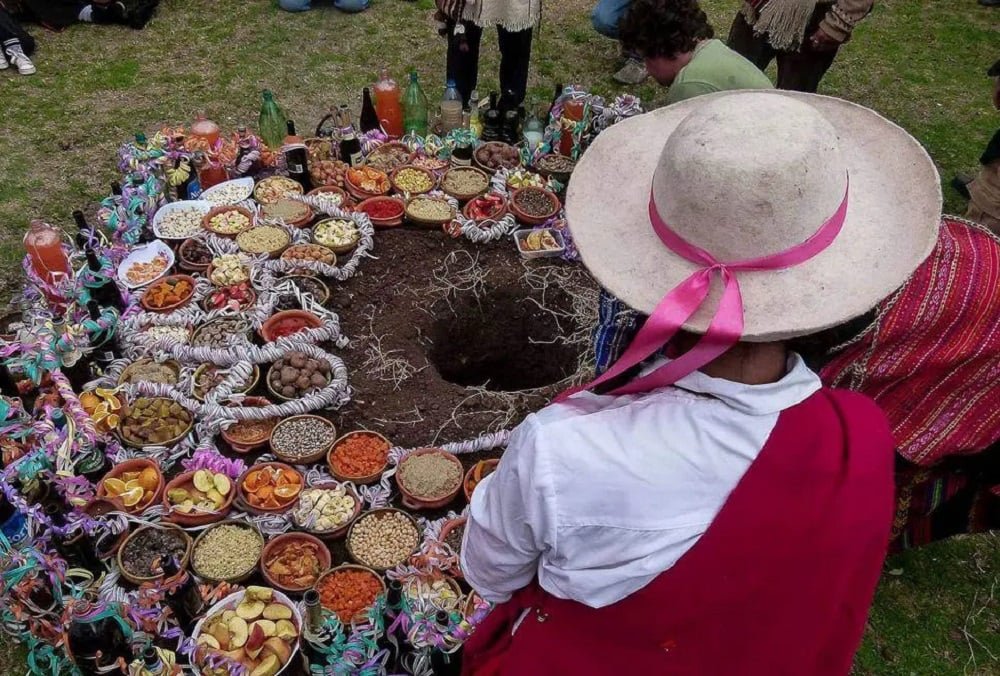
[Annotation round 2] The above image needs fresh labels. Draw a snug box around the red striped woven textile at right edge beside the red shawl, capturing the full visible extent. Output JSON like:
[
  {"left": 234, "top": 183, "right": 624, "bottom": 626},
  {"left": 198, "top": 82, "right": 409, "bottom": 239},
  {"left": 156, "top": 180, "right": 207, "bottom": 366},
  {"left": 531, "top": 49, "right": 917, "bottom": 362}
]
[{"left": 821, "top": 217, "right": 1000, "bottom": 466}]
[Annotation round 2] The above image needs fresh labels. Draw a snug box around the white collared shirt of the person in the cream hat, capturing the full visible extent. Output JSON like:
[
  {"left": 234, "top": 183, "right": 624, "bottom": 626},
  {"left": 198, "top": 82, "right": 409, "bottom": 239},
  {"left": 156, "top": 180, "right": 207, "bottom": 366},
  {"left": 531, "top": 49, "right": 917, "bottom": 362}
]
[{"left": 462, "top": 355, "right": 821, "bottom": 608}]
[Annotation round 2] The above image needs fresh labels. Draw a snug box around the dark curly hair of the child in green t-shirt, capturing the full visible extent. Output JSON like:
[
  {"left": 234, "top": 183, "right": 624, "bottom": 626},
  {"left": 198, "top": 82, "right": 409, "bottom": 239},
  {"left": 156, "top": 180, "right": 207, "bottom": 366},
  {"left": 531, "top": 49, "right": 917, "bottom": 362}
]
[{"left": 618, "top": 0, "right": 715, "bottom": 59}]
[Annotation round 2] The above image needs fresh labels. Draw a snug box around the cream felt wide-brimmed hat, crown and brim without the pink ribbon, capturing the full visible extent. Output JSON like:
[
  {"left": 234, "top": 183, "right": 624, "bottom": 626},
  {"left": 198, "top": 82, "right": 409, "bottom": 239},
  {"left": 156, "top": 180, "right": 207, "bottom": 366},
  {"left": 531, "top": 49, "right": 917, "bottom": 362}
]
[{"left": 566, "top": 91, "right": 941, "bottom": 342}]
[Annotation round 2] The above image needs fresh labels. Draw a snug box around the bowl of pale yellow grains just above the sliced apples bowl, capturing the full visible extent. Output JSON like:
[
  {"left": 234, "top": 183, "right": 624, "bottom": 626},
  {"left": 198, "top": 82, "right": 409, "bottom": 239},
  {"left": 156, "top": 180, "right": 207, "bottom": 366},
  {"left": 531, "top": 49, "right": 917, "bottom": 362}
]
[{"left": 191, "top": 520, "right": 264, "bottom": 582}]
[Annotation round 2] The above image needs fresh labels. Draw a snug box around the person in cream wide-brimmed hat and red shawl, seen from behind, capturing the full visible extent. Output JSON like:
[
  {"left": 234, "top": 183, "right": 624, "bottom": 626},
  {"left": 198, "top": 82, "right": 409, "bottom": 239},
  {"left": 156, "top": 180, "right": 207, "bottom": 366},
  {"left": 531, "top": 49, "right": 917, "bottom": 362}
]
[{"left": 462, "top": 92, "right": 941, "bottom": 676}]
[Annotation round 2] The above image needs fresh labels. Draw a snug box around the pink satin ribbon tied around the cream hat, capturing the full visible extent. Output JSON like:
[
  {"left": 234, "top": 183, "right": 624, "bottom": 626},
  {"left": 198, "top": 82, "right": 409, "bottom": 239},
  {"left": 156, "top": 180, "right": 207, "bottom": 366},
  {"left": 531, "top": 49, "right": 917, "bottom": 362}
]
[{"left": 556, "top": 177, "right": 850, "bottom": 402}]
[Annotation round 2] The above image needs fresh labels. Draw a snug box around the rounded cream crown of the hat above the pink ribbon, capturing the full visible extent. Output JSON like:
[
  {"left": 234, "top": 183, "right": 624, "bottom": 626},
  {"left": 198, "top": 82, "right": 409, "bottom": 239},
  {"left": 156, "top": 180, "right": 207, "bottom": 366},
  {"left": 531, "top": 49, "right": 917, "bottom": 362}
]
[{"left": 653, "top": 92, "right": 847, "bottom": 262}]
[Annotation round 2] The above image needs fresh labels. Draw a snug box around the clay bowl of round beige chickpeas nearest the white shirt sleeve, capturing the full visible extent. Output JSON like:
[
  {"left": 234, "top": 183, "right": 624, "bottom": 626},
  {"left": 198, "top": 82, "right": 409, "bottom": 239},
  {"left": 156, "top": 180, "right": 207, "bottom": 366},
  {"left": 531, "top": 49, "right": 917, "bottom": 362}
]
[{"left": 347, "top": 508, "right": 421, "bottom": 572}]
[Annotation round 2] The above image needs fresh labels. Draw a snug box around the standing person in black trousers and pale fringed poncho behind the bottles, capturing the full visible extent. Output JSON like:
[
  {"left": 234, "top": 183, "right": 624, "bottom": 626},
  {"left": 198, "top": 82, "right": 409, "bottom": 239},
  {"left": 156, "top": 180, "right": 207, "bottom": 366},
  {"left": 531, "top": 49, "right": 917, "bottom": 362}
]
[{"left": 435, "top": 0, "right": 542, "bottom": 110}]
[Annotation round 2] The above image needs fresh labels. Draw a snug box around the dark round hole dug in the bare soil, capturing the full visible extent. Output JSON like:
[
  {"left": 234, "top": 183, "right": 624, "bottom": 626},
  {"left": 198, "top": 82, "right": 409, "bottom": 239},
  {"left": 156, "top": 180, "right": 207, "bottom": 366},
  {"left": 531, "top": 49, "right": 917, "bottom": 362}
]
[{"left": 430, "top": 286, "right": 580, "bottom": 392}]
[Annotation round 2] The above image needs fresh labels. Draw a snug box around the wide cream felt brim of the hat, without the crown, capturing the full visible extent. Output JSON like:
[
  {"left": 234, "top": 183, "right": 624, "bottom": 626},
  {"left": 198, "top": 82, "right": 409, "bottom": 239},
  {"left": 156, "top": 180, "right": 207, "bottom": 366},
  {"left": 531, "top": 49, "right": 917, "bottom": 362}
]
[{"left": 566, "top": 91, "right": 941, "bottom": 342}]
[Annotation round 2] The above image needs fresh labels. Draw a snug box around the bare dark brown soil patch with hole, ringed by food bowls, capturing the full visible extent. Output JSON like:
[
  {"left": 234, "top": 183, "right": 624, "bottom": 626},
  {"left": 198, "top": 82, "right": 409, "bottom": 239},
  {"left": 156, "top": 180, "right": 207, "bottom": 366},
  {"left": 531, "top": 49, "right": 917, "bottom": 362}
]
[{"left": 318, "top": 229, "right": 579, "bottom": 447}]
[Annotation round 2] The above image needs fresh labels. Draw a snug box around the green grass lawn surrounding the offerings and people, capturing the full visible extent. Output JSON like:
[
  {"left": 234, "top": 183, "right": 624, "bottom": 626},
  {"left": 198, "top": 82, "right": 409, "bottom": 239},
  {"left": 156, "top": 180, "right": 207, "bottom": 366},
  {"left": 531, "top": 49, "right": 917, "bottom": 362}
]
[{"left": 0, "top": 0, "right": 1000, "bottom": 676}]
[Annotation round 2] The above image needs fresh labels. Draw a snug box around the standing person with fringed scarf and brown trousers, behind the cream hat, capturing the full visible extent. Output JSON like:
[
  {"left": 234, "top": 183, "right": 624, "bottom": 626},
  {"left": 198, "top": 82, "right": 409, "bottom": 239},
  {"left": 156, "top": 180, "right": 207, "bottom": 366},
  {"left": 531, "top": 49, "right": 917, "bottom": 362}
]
[{"left": 729, "top": 0, "right": 875, "bottom": 93}]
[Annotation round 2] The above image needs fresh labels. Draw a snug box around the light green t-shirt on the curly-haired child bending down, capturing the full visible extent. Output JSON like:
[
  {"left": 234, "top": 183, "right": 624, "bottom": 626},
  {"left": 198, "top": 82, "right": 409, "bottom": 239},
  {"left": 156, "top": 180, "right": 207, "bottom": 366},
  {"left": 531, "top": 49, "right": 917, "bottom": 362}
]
[{"left": 667, "top": 40, "right": 774, "bottom": 104}]
